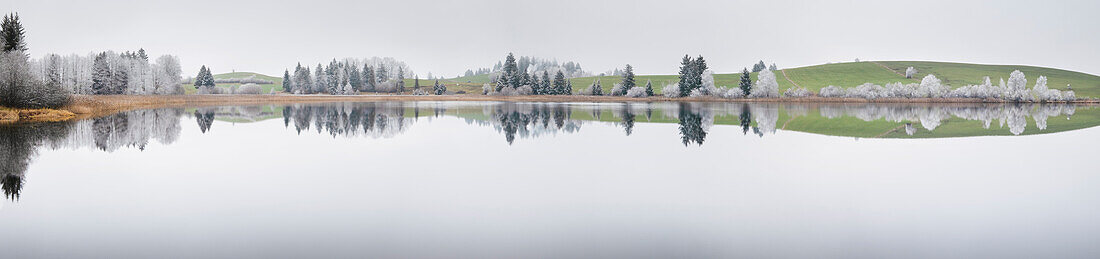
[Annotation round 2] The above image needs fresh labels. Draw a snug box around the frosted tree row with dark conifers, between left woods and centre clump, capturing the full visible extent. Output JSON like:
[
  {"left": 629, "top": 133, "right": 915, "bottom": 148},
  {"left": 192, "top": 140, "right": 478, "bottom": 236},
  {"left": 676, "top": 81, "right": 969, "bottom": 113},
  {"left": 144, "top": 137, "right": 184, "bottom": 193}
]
[{"left": 283, "top": 57, "right": 411, "bottom": 95}]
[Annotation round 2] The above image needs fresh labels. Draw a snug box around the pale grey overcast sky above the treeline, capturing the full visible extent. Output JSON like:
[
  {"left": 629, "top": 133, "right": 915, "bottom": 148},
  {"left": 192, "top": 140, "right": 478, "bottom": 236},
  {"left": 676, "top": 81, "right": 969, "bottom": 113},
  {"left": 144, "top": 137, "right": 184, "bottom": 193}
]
[{"left": 0, "top": 0, "right": 1100, "bottom": 77}]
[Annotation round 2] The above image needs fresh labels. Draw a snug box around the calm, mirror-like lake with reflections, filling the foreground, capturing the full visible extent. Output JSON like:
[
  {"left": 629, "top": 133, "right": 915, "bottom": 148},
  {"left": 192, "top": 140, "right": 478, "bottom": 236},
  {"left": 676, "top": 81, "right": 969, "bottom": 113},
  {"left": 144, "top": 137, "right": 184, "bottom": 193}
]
[{"left": 0, "top": 101, "right": 1100, "bottom": 258}]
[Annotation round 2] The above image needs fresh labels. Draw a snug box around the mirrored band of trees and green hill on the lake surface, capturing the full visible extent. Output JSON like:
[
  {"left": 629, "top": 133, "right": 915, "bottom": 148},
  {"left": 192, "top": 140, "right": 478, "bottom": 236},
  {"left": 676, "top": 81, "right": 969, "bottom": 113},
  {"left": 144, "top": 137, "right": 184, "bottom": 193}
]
[{"left": 0, "top": 102, "right": 1100, "bottom": 199}]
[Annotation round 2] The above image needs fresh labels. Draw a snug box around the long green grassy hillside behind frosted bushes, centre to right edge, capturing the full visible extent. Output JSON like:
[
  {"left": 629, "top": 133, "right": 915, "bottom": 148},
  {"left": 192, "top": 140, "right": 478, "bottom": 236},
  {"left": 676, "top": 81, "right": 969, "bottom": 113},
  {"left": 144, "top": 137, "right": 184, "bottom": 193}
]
[{"left": 446, "top": 61, "right": 1100, "bottom": 97}]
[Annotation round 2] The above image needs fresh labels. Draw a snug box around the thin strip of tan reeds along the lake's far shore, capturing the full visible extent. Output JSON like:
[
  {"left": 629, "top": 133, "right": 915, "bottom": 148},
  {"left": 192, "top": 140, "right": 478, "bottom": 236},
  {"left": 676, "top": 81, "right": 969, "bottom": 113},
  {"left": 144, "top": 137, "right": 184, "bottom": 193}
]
[{"left": 0, "top": 94, "right": 1100, "bottom": 125}]
